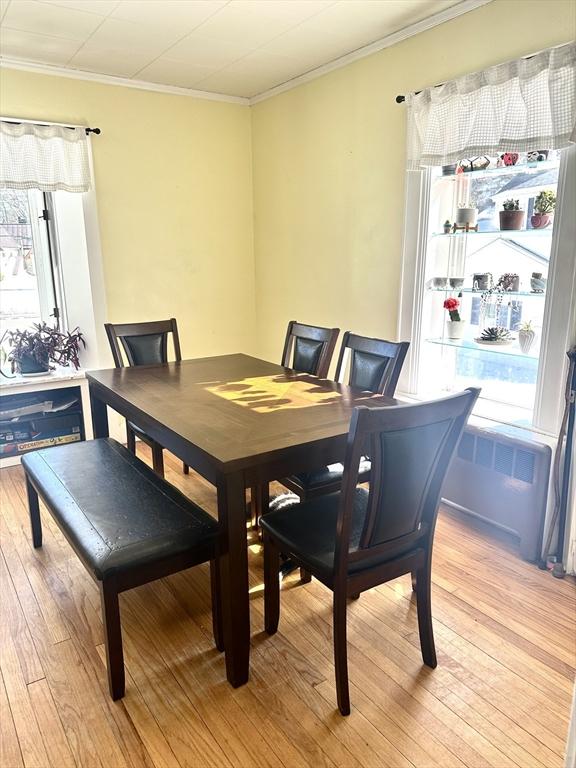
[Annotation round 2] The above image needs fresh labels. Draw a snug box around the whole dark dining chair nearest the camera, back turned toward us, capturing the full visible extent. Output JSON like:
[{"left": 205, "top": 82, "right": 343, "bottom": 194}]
[{"left": 261, "top": 388, "right": 480, "bottom": 715}]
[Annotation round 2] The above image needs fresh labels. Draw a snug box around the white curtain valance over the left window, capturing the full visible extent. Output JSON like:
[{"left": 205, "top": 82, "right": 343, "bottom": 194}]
[{"left": 0, "top": 121, "right": 90, "bottom": 192}]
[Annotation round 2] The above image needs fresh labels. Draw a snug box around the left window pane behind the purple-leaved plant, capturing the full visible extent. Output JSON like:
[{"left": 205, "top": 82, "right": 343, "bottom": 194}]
[{"left": 0, "top": 189, "right": 62, "bottom": 336}]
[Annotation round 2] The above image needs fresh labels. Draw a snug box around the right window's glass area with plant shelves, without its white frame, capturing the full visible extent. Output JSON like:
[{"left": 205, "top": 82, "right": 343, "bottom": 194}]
[{"left": 418, "top": 157, "right": 558, "bottom": 424}]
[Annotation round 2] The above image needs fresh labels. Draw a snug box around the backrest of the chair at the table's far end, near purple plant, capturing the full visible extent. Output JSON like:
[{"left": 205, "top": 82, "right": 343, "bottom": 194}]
[{"left": 104, "top": 318, "right": 182, "bottom": 368}]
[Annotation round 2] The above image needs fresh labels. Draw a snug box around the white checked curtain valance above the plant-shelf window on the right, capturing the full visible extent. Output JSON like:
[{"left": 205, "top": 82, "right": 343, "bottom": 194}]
[{"left": 406, "top": 43, "right": 576, "bottom": 170}]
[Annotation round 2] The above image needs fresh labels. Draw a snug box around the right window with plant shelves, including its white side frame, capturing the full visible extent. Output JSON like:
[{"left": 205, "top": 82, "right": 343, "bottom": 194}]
[{"left": 400, "top": 142, "right": 576, "bottom": 433}]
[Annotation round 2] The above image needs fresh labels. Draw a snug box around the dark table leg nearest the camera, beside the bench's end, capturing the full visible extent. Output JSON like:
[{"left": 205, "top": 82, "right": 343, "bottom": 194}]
[{"left": 217, "top": 473, "right": 250, "bottom": 688}]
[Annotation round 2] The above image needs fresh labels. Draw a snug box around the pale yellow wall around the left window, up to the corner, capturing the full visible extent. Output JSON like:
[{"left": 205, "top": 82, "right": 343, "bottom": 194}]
[{"left": 0, "top": 69, "right": 255, "bottom": 357}]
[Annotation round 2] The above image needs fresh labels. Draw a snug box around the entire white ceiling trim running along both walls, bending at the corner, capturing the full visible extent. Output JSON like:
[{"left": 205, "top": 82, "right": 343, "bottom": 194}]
[{"left": 0, "top": 0, "right": 492, "bottom": 106}]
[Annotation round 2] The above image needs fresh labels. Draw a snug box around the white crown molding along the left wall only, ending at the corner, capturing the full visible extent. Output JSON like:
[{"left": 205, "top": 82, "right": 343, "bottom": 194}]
[{"left": 0, "top": 56, "right": 250, "bottom": 106}]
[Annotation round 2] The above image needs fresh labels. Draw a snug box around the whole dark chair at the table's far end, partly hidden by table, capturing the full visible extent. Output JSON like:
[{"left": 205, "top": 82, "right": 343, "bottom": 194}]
[{"left": 104, "top": 317, "right": 190, "bottom": 477}]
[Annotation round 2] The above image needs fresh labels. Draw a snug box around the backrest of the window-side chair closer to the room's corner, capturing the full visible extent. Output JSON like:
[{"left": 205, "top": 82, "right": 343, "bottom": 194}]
[{"left": 281, "top": 320, "right": 340, "bottom": 379}]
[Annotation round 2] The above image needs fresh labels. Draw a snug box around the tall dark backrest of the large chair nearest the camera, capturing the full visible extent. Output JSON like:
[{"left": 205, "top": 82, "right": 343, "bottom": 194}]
[{"left": 335, "top": 388, "right": 480, "bottom": 571}]
